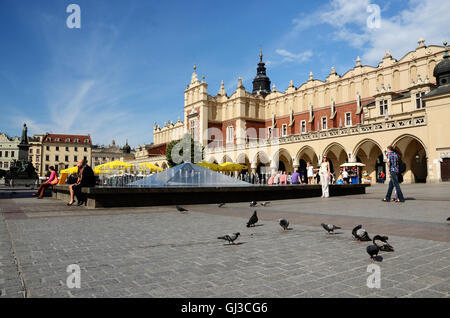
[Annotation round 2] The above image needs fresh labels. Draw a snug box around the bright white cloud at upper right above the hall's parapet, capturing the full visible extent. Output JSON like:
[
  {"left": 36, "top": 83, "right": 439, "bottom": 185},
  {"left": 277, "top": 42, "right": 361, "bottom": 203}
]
[{"left": 285, "top": 0, "right": 450, "bottom": 65}]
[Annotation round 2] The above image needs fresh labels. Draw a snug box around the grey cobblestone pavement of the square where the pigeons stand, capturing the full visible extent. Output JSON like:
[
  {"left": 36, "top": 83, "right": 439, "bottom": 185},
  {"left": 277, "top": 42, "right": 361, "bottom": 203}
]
[{"left": 0, "top": 184, "right": 450, "bottom": 297}]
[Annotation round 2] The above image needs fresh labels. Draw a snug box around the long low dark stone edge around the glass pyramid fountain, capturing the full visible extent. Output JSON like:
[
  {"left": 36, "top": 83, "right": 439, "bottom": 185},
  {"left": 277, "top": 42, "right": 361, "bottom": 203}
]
[{"left": 52, "top": 184, "right": 370, "bottom": 209}]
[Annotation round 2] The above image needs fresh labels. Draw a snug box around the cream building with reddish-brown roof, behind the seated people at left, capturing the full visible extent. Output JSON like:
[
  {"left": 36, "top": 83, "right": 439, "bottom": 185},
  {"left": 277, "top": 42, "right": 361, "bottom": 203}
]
[{"left": 39, "top": 133, "right": 92, "bottom": 176}]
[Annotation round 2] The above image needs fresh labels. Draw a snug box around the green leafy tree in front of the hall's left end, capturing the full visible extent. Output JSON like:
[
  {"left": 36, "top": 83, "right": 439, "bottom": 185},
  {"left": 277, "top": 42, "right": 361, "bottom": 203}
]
[{"left": 166, "top": 134, "right": 204, "bottom": 168}]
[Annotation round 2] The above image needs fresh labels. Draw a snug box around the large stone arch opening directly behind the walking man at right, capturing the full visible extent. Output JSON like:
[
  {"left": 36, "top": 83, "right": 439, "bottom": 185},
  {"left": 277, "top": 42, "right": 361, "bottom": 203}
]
[{"left": 392, "top": 134, "right": 428, "bottom": 183}]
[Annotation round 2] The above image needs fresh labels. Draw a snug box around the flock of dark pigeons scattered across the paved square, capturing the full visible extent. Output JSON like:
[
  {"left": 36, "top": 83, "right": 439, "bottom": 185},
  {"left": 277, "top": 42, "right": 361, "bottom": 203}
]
[{"left": 175, "top": 201, "right": 394, "bottom": 261}]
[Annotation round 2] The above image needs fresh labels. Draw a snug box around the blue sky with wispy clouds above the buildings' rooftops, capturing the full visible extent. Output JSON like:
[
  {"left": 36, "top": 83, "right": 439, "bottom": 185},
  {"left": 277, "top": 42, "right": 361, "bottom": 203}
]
[{"left": 0, "top": 0, "right": 450, "bottom": 147}]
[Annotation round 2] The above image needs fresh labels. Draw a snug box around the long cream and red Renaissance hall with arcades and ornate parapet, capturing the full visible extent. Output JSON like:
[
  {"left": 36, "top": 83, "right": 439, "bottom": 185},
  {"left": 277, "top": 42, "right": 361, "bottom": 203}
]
[{"left": 149, "top": 39, "right": 450, "bottom": 183}]
